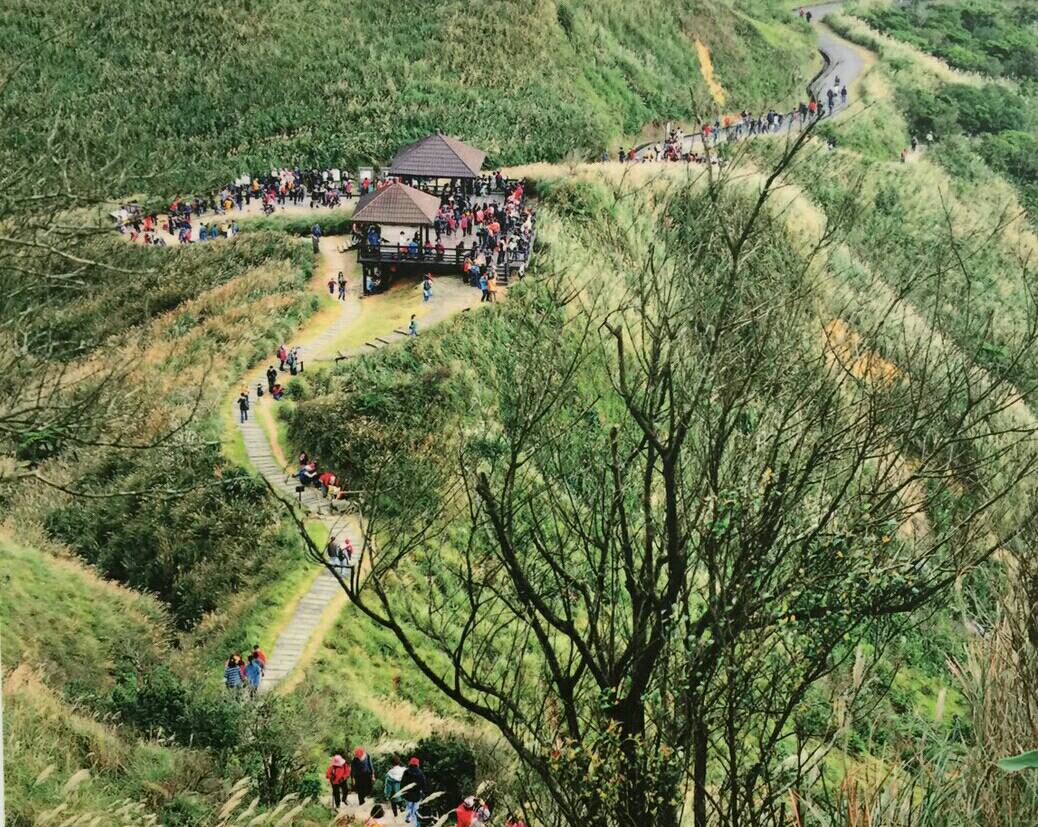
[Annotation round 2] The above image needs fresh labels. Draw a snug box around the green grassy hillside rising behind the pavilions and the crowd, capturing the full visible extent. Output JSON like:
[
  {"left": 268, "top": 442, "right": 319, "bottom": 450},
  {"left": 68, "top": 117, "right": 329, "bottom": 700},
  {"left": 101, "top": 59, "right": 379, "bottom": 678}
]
[{"left": 0, "top": 0, "right": 816, "bottom": 195}]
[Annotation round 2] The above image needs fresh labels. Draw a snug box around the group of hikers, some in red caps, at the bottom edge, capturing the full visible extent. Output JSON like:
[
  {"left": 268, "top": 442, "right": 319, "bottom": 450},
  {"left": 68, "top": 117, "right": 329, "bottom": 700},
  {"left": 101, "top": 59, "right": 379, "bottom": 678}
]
[{"left": 325, "top": 747, "right": 526, "bottom": 827}]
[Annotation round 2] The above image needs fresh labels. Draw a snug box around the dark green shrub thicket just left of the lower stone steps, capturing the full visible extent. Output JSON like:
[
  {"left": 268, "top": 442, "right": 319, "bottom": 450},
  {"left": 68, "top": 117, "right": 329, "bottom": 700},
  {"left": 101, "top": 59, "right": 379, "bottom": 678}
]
[{"left": 44, "top": 444, "right": 279, "bottom": 628}]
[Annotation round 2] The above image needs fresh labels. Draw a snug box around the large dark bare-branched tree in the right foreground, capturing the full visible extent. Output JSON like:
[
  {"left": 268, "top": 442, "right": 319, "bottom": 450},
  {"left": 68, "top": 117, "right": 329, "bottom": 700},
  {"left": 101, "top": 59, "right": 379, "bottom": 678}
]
[{"left": 284, "top": 139, "right": 1038, "bottom": 827}]
